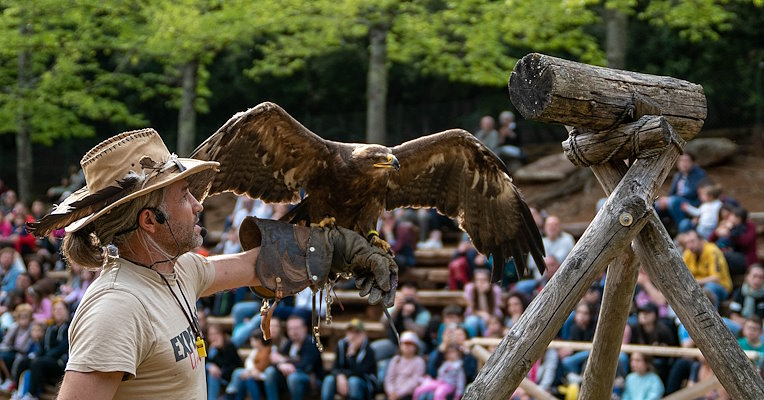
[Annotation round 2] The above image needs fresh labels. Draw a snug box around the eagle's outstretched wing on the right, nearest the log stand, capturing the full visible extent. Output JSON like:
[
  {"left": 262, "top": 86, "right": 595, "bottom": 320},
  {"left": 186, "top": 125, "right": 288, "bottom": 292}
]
[{"left": 386, "top": 129, "right": 544, "bottom": 282}]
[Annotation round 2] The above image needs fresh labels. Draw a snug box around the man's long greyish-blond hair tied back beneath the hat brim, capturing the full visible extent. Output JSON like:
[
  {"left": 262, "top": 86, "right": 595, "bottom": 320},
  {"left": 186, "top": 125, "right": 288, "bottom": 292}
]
[{"left": 61, "top": 188, "right": 167, "bottom": 270}]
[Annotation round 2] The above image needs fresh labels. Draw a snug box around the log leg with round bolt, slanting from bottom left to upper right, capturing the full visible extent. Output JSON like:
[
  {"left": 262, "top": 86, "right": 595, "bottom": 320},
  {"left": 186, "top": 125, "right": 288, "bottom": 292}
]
[{"left": 465, "top": 142, "right": 679, "bottom": 399}]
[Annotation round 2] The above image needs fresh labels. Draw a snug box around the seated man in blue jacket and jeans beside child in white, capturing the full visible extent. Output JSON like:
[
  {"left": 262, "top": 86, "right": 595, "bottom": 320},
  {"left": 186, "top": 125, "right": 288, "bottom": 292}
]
[{"left": 655, "top": 153, "right": 706, "bottom": 233}]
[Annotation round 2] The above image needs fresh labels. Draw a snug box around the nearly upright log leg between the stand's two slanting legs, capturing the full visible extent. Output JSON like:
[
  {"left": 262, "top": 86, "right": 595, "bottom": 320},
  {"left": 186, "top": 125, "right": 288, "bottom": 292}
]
[{"left": 579, "top": 248, "right": 639, "bottom": 399}]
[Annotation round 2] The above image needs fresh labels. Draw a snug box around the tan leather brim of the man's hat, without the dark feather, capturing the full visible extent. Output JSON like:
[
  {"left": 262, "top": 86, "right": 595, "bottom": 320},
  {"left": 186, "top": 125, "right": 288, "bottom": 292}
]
[{"left": 62, "top": 158, "right": 220, "bottom": 233}]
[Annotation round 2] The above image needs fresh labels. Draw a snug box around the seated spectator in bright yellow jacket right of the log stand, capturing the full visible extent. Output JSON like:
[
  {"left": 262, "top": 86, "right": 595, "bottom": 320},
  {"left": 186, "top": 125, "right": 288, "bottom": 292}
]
[{"left": 680, "top": 231, "right": 732, "bottom": 309}]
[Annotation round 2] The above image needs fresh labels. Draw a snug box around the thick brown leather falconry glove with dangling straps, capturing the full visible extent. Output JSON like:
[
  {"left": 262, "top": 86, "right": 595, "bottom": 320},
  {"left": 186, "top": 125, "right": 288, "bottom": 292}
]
[{"left": 239, "top": 217, "right": 398, "bottom": 349}]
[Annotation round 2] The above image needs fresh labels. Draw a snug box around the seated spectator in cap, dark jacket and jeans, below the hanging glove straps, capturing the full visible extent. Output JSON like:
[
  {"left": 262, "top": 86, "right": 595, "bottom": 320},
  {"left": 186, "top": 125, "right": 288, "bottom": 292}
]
[{"left": 321, "top": 318, "right": 377, "bottom": 400}]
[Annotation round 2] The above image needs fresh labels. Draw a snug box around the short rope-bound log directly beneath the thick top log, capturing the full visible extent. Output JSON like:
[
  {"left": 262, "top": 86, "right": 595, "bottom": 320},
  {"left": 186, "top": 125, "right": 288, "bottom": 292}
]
[{"left": 562, "top": 115, "right": 672, "bottom": 167}]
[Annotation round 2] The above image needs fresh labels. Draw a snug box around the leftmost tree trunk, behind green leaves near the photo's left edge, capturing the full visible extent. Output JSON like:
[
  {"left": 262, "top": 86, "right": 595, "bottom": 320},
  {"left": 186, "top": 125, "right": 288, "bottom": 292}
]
[{"left": 16, "top": 24, "right": 34, "bottom": 204}]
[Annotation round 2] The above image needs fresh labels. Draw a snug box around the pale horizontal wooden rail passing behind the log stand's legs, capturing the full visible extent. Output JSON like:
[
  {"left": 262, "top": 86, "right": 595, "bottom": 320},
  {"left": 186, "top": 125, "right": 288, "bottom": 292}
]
[{"left": 467, "top": 338, "right": 760, "bottom": 361}]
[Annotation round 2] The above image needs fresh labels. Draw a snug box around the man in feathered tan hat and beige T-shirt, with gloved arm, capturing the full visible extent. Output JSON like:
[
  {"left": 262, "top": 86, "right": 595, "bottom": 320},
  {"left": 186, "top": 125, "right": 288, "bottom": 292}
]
[{"left": 30, "top": 129, "right": 397, "bottom": 399}]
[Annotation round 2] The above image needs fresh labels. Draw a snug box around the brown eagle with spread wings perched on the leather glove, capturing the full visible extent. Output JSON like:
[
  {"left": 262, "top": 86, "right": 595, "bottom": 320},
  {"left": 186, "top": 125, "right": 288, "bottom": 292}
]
[{"left": 190, "top": 102, "right": 544, "bottom": 282}]
